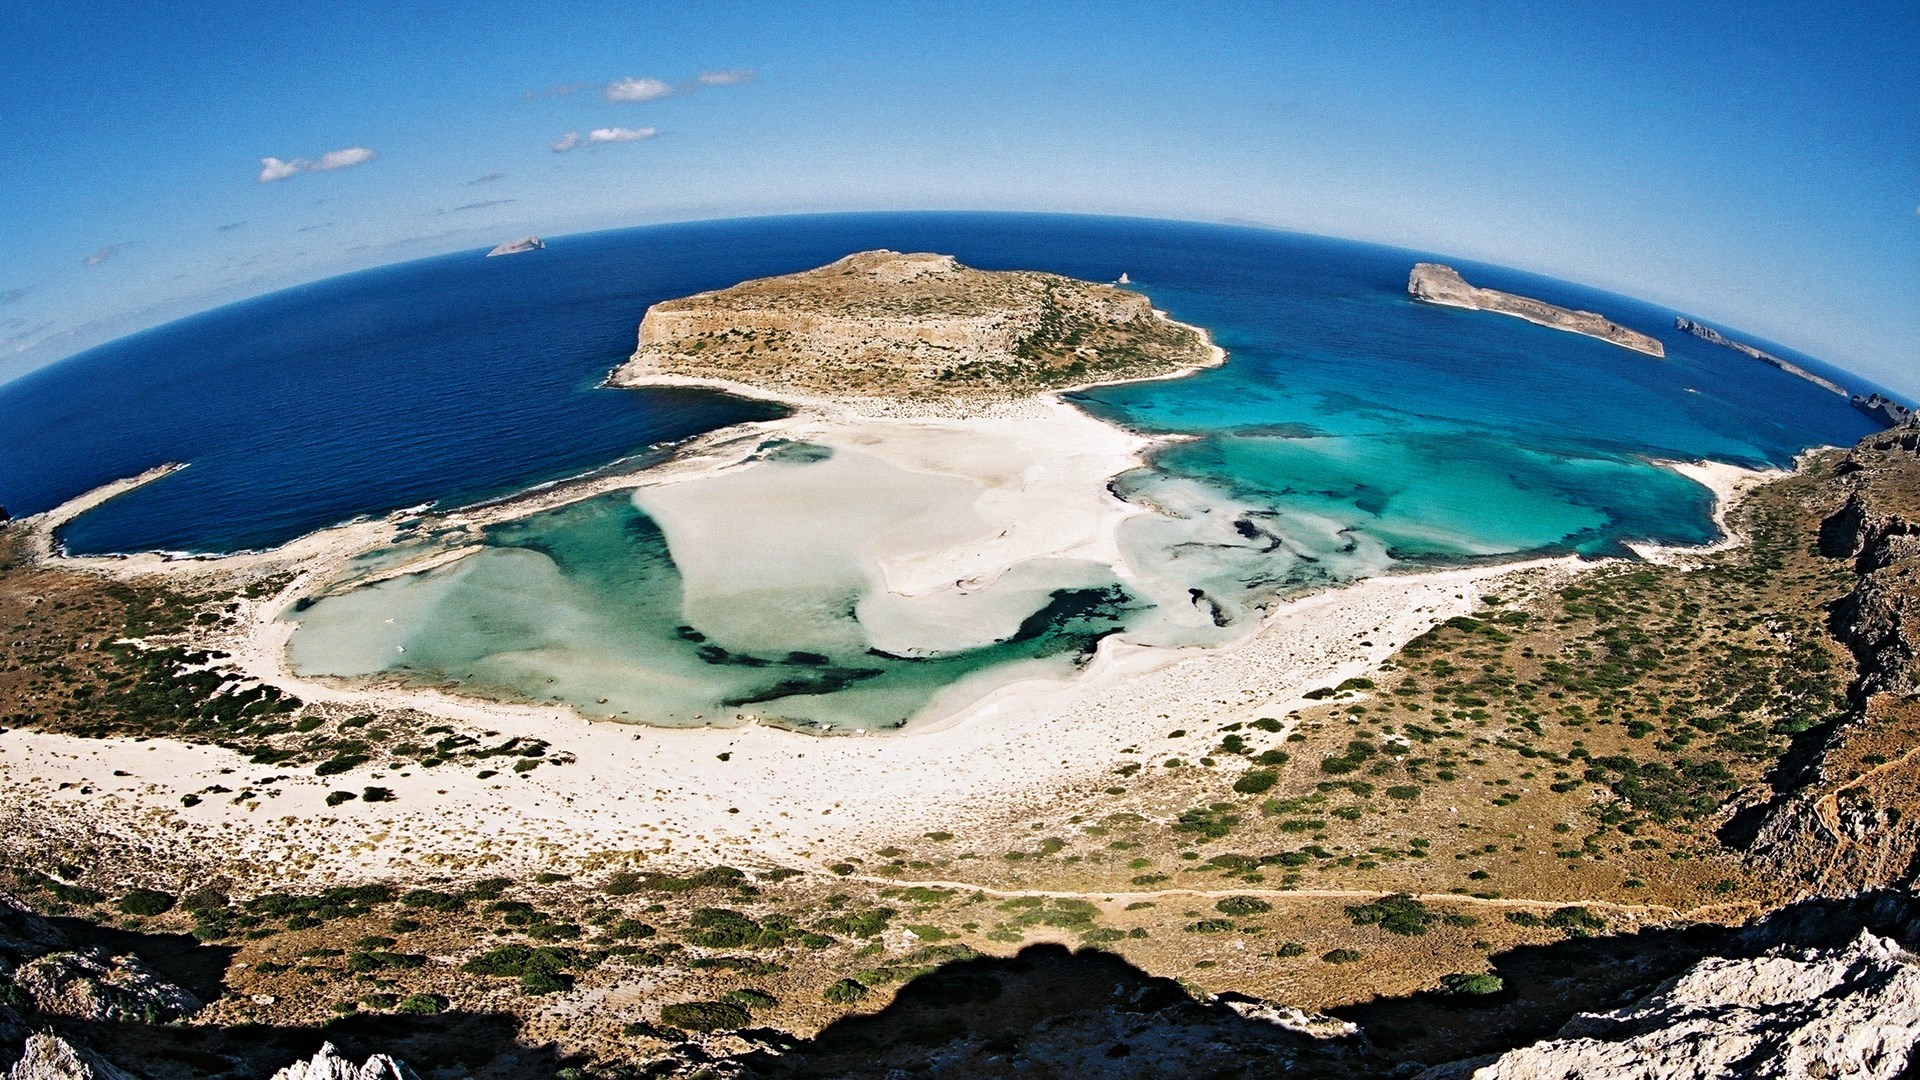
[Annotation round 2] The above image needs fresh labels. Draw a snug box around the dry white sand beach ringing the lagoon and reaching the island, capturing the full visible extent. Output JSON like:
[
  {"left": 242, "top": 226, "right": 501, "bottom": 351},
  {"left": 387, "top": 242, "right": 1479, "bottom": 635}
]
[{"left": 0, "top": 288, "right": 1820, "bottom": 880}]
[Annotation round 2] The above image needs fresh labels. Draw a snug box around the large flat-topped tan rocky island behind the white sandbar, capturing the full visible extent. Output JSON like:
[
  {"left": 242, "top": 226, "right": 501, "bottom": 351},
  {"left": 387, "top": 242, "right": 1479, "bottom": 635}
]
[{"left": 609, "top": 250, "right": 1219, "bottom": 404}]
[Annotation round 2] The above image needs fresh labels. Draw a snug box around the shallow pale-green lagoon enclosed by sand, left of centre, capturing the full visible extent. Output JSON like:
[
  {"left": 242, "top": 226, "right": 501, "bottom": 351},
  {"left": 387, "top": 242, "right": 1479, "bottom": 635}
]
[{"left": 290, "top": 492, "right": 1133, "bottom": 730}]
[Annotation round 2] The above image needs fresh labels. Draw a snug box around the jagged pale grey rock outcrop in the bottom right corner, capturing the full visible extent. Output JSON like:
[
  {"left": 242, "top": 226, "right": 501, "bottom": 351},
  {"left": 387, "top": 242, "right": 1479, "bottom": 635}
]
[{"left": 1419, "top": 932, "right": 1920, "bottom": 1080}]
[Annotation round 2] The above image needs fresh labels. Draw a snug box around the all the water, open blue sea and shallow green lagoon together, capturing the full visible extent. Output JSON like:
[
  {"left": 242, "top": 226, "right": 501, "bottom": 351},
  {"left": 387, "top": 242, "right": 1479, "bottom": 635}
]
[{"left": 0, "top": 213, "right": 1874, "bottom": 728}]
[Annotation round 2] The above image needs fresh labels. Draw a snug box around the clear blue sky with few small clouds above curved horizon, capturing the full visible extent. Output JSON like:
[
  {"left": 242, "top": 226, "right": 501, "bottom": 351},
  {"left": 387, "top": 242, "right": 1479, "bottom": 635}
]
[{"left": 0, "top": 0, "right": 1920, "bottom": 394}]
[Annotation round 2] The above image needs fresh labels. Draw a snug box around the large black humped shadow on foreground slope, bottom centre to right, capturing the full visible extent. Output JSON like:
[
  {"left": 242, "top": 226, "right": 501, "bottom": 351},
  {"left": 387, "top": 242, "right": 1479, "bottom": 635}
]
[{"left": 749, "top": 894, "right": 1920, "bottom": 1080}]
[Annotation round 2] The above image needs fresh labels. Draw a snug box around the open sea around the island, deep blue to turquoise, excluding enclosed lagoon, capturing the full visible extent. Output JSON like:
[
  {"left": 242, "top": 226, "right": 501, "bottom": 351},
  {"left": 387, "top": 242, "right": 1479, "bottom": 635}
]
[{"left": 0, "top": 213, "right": 1876, "bottom": 559}]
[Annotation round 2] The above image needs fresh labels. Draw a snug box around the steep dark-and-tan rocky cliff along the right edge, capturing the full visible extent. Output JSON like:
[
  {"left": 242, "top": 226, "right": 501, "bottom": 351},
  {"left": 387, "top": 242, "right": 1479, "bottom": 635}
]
[{"left": 1749, "top": 421, "right": 1920, "bottom": 896}]
